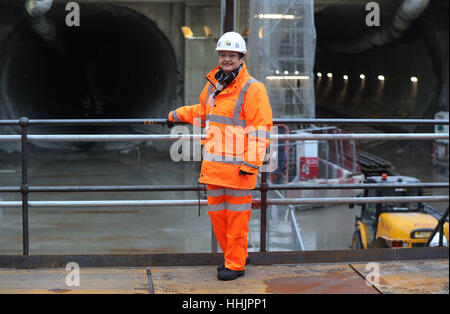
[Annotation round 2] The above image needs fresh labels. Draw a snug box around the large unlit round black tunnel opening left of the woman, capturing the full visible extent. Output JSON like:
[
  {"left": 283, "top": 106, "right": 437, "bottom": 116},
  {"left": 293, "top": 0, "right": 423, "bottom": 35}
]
[{"left": 0, "top": 4, "right": 178, "bottom": 150}]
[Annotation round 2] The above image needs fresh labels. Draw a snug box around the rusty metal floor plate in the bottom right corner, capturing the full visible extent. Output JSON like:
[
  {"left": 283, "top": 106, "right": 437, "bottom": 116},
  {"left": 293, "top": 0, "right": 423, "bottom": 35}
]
[{"left": 352, "top": 260, "right": 449, "bottom": 294}]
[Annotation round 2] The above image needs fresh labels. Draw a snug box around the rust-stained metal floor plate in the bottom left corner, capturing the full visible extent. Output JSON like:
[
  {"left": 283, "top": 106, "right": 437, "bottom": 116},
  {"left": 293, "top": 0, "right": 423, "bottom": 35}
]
[{"left": 0, "top": 268, "right": 149, "bottom": 294}]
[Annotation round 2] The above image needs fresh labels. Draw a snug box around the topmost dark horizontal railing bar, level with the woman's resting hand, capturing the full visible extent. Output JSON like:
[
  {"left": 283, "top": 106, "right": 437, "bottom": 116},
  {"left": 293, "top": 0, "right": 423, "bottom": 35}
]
[{"left": 0, "top": 118, "right": 449, "bottom": 125}]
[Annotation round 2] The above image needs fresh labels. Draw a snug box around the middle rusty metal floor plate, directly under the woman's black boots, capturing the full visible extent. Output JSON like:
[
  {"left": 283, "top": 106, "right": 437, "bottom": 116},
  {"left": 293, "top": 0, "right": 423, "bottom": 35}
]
[{"left": 151, "top": 264, "right": 378, "bottom": 294}]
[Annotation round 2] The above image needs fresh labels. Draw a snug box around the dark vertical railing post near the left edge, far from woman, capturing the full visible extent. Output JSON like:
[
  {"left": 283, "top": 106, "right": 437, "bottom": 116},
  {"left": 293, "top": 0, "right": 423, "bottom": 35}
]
[{"left": 19, "top": 117, "right": 30, "bottom": 256}]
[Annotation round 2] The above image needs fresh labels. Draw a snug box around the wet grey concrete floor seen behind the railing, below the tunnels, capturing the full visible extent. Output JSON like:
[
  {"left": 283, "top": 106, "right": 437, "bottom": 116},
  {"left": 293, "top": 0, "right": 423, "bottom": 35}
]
[{"left": 0, "top": 135, "right": 448, "bottom": 255}]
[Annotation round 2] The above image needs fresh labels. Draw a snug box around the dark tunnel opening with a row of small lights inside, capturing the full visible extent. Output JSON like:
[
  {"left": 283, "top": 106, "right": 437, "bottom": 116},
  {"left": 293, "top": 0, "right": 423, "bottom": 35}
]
[{"left": 314, "top": 4, "right": 448, "bottom": 130}]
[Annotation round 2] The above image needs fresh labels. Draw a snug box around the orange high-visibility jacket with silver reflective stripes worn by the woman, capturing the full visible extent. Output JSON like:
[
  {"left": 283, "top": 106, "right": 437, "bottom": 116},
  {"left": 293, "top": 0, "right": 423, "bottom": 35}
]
[{"left": 169, "top": 64, "right": 273, "bottom": 189}]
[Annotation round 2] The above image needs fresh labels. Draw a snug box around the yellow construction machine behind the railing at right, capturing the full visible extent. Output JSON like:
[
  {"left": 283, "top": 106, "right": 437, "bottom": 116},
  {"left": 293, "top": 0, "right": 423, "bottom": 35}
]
[{"left": 350, "top": 175, "right": 449, "bottom": 249}]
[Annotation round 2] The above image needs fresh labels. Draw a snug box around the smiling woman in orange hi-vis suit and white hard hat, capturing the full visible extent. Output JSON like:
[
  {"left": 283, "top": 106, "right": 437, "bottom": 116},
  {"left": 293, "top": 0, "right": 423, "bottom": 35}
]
[{"left": 169, "top": 32, "right": 272, "bottom": 280}]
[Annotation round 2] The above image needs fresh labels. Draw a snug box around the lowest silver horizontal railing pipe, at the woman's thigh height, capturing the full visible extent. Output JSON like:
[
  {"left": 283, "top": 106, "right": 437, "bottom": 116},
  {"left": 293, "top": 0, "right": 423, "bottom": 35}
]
[{"left": 0, "top": 195, "right": 449, "bottom": 207}]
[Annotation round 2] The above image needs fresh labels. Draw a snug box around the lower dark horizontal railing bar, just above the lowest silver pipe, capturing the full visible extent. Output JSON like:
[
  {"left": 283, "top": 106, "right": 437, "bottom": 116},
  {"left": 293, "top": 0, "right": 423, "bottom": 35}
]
[{"left": 0, "top": 182, "right": 450, "bottom": 193}]
